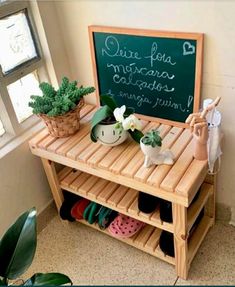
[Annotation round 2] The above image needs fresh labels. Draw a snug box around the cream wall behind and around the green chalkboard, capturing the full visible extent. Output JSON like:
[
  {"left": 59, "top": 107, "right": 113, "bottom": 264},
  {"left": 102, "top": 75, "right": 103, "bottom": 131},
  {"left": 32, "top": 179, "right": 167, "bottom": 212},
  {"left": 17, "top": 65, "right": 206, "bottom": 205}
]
[{"left": 55, "top": 0, "right": 235, "bottom": 209}]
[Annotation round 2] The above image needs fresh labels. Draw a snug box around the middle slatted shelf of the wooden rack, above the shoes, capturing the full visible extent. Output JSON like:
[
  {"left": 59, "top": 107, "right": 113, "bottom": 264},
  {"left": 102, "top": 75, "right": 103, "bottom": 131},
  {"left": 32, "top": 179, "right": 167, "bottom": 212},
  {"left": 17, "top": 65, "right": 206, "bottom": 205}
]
[{"left": 58, "top": 167, "right": 173, "bottom": 232}]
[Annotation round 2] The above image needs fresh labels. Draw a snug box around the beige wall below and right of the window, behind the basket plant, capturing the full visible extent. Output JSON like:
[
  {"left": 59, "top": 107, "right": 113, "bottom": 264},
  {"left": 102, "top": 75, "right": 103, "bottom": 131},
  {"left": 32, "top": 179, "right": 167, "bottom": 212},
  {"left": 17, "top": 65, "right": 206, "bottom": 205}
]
[{"left": 0, "top": 1, "right": 71, "bottom": 237}]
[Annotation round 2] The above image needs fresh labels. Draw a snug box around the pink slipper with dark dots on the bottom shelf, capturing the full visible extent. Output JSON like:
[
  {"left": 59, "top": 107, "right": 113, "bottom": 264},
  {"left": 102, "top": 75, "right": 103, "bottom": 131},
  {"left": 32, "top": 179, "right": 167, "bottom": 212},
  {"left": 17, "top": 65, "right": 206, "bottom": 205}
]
[{"left": 108, "top": 214, "right": 145, "bottom": 238}]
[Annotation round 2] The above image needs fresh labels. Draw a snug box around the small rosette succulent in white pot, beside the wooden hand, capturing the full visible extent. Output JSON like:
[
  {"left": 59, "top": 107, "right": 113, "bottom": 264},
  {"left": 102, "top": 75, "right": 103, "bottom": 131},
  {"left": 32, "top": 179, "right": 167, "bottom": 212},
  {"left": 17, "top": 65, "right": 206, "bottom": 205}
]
[{"left": 140, "top": 129, "right": 162, "bottom": 167}]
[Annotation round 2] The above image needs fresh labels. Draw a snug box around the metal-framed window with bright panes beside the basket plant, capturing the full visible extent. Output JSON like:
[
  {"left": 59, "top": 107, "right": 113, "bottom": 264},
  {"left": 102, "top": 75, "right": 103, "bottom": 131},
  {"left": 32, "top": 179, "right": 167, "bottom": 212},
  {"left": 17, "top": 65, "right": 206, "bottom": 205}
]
[{"left": 0, "top": 1, "right": 47, "bottom": 146}]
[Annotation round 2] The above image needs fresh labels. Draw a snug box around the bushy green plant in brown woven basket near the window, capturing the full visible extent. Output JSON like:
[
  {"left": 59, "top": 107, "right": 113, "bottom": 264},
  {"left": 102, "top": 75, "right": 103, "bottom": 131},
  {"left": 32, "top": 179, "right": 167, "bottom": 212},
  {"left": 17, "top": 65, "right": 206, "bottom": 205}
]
[{"left": 29, "top": 77, "right": 95, "bottom": 137}]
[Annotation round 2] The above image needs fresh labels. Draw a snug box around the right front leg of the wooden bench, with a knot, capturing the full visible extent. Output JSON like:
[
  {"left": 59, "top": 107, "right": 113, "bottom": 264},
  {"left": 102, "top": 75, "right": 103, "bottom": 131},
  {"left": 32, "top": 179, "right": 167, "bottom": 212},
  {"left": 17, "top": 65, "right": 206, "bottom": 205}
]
[{"left": 172, "top": 203, "right": 189, "bottom": 280}]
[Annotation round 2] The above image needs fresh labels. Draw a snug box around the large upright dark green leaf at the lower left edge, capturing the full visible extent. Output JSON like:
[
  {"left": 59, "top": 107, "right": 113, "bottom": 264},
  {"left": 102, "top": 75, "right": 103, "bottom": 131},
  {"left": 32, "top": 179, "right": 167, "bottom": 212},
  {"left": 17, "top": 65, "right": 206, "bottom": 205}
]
[{"left": 0, "top": 208, "right": 37, "bottom": 279}]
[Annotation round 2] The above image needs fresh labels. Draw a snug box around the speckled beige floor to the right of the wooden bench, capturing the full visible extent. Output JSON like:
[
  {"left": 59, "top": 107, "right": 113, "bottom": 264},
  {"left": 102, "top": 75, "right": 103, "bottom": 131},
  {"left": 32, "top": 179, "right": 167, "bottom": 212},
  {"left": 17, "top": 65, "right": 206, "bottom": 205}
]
[{"left": 176, "top": 223, "right": 235, "bottom": 285}]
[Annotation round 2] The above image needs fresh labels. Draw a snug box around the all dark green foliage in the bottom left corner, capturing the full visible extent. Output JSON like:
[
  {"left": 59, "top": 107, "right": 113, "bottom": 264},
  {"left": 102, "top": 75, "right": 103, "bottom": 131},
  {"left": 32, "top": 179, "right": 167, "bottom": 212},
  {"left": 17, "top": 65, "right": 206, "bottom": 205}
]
[{"left": 0, "top": 208, "right": 72, "bottom": 286}]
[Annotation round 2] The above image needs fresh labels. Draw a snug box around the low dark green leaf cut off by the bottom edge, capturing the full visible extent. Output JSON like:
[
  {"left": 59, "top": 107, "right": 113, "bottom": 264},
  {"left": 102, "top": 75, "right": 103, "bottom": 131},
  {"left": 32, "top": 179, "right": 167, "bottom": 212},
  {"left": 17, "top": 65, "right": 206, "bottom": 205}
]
[{"left": 24, "top": 273, "right": 72, "bottom": 286}]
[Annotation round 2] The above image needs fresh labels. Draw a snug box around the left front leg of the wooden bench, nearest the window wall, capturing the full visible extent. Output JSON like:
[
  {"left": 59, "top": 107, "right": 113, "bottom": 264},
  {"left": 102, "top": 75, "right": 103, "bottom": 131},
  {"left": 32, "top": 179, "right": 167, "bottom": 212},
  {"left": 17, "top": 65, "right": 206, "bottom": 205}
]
[{"left": 41, "top": 158, "right": 64, "bottom": 211}]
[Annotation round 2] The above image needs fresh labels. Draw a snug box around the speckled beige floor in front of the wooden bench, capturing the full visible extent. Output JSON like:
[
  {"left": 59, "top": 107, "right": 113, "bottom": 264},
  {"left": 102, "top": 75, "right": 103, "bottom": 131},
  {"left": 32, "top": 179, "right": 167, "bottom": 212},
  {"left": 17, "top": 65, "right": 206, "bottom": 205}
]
[{"left": 25, "top": 217, "right": 176, "bottom": 285}]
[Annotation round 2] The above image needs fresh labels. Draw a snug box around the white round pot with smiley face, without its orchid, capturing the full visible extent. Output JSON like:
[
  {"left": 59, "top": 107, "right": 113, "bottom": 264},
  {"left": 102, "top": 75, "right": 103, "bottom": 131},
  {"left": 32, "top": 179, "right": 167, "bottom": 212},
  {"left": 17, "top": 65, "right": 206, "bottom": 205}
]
[{"left": 94, "top": 122, "right": 128, "bottom": 146}]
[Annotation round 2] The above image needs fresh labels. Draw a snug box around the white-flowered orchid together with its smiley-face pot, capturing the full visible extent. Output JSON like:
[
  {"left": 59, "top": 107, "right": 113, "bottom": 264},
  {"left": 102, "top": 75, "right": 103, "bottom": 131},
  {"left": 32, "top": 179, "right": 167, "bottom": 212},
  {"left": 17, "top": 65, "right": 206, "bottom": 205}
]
[{"left": 90, "top": 95, "right": 143, "bottom": 146}]
